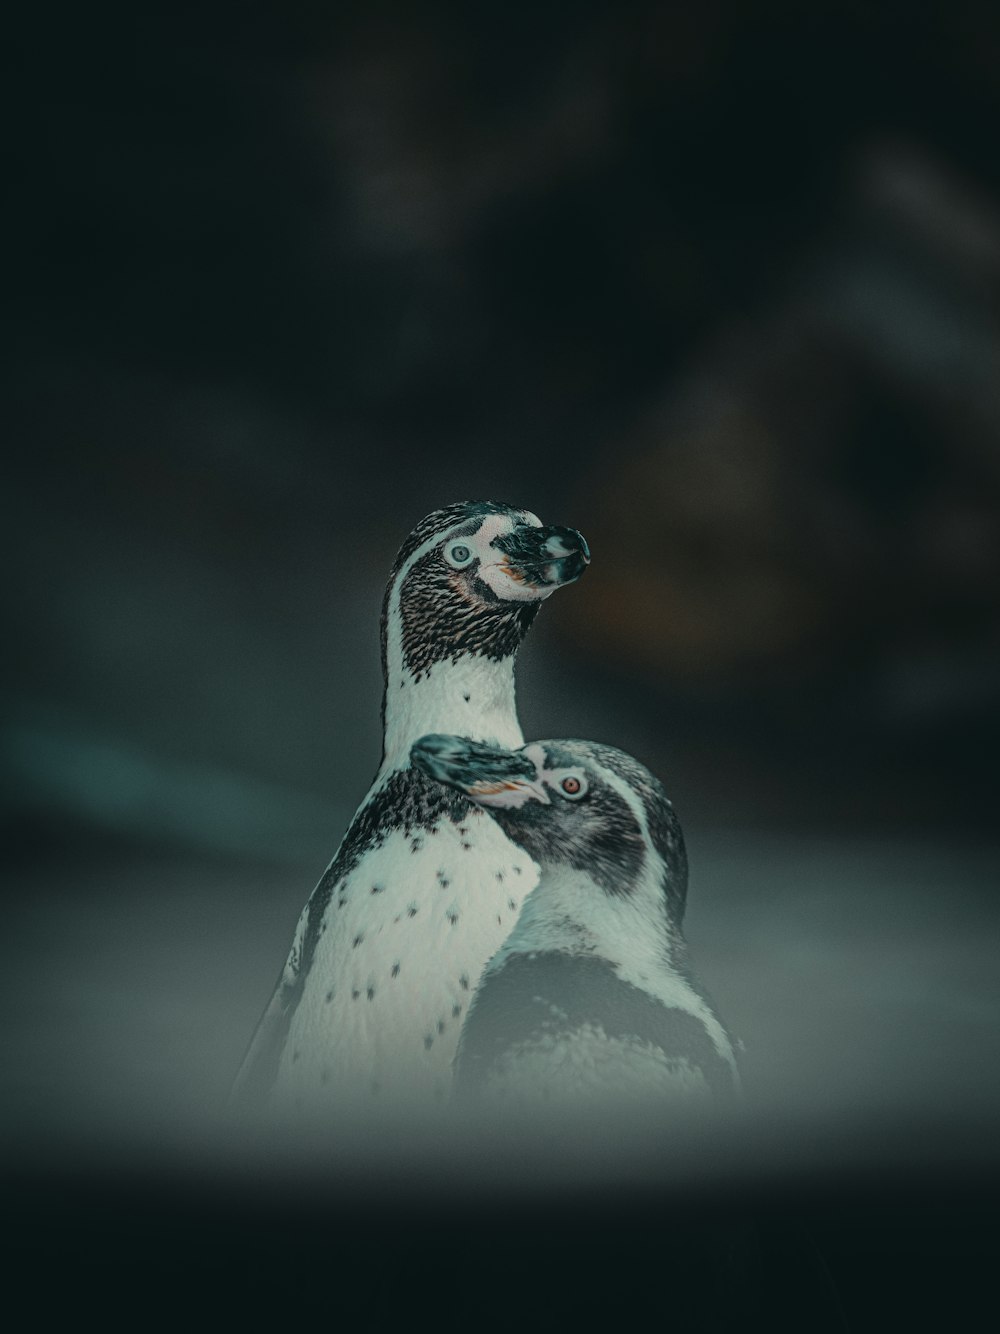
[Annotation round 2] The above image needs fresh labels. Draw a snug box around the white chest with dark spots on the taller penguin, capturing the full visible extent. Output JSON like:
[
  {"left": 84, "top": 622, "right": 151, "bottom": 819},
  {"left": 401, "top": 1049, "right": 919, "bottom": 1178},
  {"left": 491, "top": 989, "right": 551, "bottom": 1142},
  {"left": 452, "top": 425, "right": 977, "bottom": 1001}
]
[{"left": 272, "top": 810, "right": 537, "bottom": 1110}]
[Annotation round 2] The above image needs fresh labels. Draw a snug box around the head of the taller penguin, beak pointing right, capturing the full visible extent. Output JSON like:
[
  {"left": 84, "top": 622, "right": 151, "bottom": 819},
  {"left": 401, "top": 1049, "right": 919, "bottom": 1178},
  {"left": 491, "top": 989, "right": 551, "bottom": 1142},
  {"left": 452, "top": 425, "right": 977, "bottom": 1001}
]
[{"left": 383, "top": 500, "right": 591, "bottom": 679}]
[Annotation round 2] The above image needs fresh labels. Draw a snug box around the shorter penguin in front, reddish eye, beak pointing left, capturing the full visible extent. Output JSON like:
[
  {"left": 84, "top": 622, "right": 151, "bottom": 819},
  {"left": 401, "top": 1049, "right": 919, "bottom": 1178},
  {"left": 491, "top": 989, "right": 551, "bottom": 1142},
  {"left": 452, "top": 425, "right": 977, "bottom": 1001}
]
[{"left": 412, "top": 736, "right": 739, "bottom": 1111}]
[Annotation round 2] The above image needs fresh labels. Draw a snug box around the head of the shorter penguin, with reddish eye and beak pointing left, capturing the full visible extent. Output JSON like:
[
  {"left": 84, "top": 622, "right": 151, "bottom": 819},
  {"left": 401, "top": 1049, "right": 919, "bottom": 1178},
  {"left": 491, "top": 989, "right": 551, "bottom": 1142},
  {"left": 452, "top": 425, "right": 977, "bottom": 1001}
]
[{"left": 411, "top": 735, "right": 687, "bottom": 924}]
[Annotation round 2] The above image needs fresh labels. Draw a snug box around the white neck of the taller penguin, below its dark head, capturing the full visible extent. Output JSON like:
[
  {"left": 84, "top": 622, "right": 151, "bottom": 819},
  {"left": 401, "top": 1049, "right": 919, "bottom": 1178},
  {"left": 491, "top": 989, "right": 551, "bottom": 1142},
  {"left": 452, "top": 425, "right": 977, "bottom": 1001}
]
[{"left": 379, "top": 654, "right": 524, "bottom": 775}]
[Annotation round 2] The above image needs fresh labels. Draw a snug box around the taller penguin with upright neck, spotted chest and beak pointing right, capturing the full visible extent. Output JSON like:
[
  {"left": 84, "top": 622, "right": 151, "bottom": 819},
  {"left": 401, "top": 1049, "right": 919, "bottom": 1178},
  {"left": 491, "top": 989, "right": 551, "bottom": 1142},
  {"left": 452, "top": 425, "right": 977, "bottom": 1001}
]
[{"left": 231, "top": 502, "right": 591, "bottom": 1127}]
